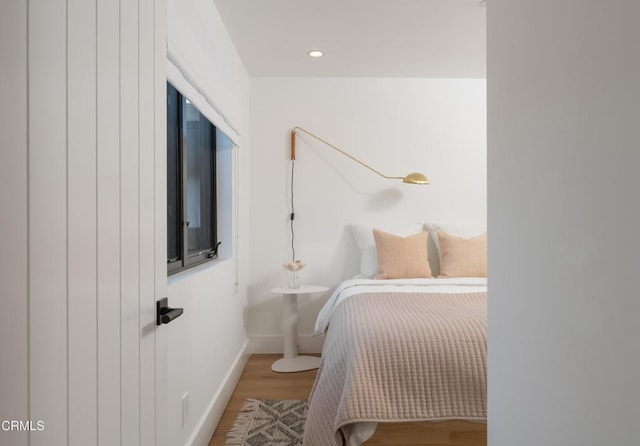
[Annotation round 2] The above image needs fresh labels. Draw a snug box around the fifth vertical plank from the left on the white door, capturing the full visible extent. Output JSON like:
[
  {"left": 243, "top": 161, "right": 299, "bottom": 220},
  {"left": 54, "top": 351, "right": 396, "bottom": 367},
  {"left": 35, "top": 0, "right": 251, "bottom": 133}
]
[{"left": 120, "top": 0, "right": 140, "bottom": 446}]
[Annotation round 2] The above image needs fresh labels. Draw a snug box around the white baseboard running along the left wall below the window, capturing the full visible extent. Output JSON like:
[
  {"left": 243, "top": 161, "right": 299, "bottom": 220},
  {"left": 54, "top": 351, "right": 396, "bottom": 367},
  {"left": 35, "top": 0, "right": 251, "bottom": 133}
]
[{"left": 186, "top": 339, "right": 251, "bottom": 446}]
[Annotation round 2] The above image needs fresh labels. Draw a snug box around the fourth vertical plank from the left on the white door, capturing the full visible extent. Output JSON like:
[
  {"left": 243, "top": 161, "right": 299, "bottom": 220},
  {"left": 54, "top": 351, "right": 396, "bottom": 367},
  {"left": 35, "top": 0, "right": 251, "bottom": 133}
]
[{"left": 97, "top": 0, "right": 121, "bottom": 446}]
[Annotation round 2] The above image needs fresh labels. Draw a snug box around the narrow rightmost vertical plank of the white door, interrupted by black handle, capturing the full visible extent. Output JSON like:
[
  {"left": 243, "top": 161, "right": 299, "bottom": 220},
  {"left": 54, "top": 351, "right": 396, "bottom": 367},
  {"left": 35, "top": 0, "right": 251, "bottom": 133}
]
[{"left": 153, "top": 0, "right": 168, "bottom": 446}]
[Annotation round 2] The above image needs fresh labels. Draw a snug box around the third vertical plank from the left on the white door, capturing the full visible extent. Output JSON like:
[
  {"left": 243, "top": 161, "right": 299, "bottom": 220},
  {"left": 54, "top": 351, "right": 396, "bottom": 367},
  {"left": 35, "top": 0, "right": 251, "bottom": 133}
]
[{"left": 67, "top": 0, "right": 98, "bottom": 446}]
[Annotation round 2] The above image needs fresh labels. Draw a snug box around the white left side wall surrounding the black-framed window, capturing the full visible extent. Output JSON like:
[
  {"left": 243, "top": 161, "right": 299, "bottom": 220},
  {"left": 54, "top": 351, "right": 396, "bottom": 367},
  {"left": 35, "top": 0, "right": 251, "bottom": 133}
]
[{"left": 167, "top": 0, "right": 249, "bottom": 446}]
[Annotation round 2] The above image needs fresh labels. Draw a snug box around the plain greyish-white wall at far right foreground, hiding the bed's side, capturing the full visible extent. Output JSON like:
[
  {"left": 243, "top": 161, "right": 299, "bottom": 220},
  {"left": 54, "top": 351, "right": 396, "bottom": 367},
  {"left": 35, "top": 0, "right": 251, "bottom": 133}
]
[{"left": 487, "top": 0, "right": 640, "bottom": 446}]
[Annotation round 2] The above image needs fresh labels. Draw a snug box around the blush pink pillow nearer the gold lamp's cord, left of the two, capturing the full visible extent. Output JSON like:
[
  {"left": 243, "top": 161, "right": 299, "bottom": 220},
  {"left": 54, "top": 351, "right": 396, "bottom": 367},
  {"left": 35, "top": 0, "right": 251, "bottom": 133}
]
[{"left": 373, "top": 229, "right": 432, "bottom": 279}]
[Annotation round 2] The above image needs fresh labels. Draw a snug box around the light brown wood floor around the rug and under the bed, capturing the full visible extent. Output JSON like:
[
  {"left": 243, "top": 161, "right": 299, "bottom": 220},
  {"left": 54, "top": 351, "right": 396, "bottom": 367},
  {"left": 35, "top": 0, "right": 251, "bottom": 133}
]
[{"left": 209, "top": 355, "right": 487, "bottom": 446}]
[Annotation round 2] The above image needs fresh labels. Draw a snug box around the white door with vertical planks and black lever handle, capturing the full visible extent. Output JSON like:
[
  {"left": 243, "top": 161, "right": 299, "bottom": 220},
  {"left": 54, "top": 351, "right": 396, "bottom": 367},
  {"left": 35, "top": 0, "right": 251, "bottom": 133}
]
[{"left": 0, "top": 0, "right": 167, "bottom": 446}]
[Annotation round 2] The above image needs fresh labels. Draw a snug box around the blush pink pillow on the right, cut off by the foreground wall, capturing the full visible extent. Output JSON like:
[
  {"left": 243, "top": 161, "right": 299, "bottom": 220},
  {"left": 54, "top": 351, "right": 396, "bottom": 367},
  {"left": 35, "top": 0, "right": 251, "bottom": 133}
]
[{"left": 438, "top": 231, "right": 487, "bottom": 277}]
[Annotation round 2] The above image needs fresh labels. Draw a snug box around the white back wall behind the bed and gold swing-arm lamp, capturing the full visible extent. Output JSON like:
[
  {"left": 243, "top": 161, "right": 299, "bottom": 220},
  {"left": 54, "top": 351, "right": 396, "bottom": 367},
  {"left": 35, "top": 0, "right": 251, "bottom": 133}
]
[{"left": 247, "top": 78, "right": 487, "bottom": 351}]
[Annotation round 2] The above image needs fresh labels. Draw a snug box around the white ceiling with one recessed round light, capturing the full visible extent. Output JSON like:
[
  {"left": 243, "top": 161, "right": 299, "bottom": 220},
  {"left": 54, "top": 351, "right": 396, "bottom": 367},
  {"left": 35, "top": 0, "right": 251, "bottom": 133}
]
[{"left": 214, "top": 0, "right": 486, "bottom": 78}]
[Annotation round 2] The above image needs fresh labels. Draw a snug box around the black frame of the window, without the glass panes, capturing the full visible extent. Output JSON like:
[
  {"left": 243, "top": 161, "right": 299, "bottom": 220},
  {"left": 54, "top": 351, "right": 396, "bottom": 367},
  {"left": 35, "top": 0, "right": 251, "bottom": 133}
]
[{"left": 166, "top": 82, "right": 220, "bottom": 276}]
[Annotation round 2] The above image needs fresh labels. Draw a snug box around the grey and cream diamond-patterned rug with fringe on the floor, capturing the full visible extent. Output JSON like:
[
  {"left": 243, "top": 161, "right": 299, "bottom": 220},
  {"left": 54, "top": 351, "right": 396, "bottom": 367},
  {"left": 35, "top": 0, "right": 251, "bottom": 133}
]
[{"left": 225, "top": 399, "right": 308, "bottom": 446}]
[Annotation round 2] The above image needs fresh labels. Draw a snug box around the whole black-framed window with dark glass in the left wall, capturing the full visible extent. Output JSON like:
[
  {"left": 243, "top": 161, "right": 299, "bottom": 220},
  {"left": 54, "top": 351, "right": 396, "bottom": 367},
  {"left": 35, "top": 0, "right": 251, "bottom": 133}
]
[{"left": 167, "top": 83, "right": 220, "bottom": 274}]
